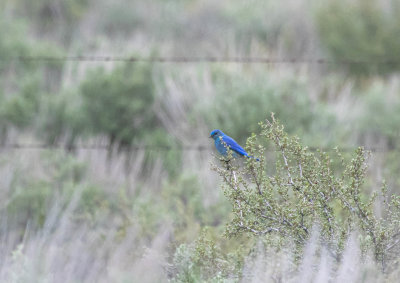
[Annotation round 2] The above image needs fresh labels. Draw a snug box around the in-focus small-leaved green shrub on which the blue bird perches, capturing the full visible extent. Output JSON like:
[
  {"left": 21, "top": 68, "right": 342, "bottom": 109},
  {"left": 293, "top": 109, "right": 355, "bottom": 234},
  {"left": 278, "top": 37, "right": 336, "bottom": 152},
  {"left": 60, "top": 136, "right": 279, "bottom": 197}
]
[{"left": 214, "top": 116, "right": 400, "bottom": 269}]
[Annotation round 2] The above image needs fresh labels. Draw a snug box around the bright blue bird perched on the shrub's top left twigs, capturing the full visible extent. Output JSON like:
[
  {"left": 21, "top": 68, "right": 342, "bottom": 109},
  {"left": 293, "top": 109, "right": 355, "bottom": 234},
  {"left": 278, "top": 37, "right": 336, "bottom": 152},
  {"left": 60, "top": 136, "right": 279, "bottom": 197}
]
[{"left": 210, "top": 130, "right": 260, "bottom": 161}]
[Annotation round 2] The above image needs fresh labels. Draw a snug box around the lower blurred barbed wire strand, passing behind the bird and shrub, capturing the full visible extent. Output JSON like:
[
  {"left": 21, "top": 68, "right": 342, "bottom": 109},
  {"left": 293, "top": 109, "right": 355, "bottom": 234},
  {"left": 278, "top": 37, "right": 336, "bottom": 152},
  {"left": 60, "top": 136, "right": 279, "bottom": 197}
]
[{"left": 0, "top": 143, "right": 400, "bottom": 153}]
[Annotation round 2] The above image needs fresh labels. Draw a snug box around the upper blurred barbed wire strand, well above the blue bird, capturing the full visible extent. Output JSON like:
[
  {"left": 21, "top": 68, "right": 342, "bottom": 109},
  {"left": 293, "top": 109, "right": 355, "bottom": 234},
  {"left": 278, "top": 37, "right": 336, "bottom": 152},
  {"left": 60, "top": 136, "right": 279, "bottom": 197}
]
[{"left": 0, "top": 55, "right": 400, "bottom": 64}]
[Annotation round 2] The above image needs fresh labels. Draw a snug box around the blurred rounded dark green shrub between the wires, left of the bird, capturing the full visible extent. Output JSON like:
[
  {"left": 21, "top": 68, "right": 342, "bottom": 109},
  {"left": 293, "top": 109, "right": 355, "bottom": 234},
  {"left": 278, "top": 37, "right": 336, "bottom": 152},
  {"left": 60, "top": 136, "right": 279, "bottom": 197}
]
[{"left": 81, "top": 63, "right": 155, "bottom": 148}]
